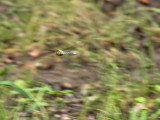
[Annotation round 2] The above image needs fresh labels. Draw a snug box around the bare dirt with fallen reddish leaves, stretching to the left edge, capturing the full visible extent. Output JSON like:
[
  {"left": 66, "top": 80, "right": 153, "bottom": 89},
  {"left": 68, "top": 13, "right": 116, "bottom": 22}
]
[{"left": 1, "top": 52, "right": 98, "bottom": 89}]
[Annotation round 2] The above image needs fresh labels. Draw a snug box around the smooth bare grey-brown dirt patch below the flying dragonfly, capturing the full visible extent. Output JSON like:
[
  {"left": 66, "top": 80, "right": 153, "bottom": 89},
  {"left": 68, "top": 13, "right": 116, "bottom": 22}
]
[{"left": 36, "top": 63, "right": 98, "bottom": 87}]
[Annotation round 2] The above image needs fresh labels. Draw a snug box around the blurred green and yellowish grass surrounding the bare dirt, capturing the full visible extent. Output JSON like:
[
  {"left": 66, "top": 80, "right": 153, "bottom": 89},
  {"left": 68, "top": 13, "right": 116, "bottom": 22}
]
[{"left": 0, "top": 0, "right": 160, "bottom": 120}]
